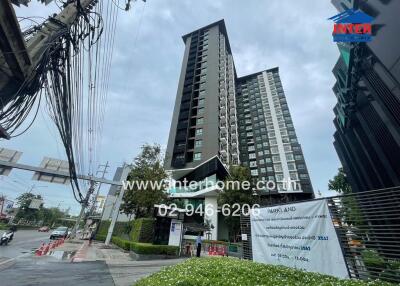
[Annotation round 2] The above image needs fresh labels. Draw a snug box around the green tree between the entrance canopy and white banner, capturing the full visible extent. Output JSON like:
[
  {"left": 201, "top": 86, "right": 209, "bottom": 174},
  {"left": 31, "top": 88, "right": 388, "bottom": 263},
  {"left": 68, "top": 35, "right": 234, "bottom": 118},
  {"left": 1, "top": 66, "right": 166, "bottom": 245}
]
[{"left": 218, "top": 166, "right": 258, "bottom": 242}]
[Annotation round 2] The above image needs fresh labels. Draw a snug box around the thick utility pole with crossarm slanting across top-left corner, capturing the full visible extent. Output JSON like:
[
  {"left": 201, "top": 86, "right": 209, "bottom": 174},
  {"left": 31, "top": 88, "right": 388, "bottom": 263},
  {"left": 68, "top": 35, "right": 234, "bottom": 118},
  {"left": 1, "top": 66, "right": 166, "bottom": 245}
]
[{"left": 0, "top": 0, "right": 97, "bottom": 111}]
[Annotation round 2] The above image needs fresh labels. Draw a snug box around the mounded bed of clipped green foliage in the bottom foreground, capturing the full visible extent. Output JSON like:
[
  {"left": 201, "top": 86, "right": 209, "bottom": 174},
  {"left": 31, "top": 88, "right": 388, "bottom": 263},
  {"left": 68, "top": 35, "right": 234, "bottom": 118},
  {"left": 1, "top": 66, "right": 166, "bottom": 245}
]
[{"left": 135, "top": 257, "right": 392, "bottom": 286}]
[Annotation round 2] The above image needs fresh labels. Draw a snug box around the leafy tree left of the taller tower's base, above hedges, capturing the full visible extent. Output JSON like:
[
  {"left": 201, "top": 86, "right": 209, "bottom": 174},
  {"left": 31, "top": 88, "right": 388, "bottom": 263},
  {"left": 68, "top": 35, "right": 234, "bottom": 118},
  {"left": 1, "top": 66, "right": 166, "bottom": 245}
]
[{"left": 121, "top": 144, "right": 167, "bottom": 218}]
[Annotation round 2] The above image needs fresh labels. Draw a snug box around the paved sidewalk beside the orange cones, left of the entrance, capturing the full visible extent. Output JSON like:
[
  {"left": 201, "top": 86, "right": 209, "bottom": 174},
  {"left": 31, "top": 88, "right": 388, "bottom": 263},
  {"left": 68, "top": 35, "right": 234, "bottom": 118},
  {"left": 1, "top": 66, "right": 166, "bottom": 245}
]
[{"left": 56, "top": 240, "right": 185, "bottom": 286}]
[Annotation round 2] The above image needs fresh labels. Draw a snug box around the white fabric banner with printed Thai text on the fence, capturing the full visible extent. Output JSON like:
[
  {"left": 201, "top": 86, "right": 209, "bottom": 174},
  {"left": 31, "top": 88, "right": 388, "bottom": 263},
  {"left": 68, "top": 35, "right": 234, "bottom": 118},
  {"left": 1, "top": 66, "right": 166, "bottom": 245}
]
[{"left": 250, "top": 200, "right": 348, "bottom": 278}]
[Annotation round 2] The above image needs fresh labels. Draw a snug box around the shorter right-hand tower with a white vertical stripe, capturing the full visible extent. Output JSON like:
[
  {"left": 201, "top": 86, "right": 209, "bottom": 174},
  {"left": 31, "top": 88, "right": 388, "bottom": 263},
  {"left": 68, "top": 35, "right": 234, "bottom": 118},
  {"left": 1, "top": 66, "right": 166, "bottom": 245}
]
[{"left": 236, "top": 68, "right": 312, "bottom": 194}]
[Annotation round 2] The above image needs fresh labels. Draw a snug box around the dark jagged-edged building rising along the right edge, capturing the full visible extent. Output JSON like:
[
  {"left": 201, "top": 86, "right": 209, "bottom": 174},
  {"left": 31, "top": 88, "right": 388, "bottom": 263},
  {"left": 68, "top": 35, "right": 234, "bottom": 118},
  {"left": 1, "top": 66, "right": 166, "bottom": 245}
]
[{"left": 332, "top": 0, "right": 400, "bottom": 192}]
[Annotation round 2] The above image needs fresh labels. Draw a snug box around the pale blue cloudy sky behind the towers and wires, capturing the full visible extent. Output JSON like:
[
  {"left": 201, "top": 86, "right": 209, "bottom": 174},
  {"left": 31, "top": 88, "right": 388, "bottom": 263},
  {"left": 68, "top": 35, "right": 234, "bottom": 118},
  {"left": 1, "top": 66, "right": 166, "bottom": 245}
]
[{"left": 0, "top": 0, "right": 340, "bottom": 214}]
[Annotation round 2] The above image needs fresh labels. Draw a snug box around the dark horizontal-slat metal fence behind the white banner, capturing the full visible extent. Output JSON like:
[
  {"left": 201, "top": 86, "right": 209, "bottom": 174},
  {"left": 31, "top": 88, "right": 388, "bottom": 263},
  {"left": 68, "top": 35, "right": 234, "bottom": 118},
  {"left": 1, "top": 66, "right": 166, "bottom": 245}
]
[{"left": 241, "top": 187, "right": 400, "bottom": 283}]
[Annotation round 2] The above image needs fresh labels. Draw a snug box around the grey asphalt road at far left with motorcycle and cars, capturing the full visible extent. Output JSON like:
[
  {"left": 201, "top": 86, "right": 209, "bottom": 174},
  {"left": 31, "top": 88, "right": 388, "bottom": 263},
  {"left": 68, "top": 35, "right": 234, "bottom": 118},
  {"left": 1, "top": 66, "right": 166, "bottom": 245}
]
[{"left": 0, "top": 230, "right": 50, "bottom": 268}]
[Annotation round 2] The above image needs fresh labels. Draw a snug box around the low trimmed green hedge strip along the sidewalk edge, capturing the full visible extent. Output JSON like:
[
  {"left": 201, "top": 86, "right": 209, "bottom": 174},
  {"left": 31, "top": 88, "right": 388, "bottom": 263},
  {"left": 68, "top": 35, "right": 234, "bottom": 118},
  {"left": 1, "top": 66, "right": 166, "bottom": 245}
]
[{"left": 111, "top": 236, "right": 179, "bottom": 256}]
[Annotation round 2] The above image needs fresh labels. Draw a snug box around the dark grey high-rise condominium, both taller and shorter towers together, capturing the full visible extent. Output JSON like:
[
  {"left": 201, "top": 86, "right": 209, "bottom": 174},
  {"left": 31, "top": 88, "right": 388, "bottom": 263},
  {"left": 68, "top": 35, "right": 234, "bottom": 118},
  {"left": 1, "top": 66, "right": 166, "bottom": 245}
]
[{"left": 165, "top": 20, "right": 313, "bottom": 199}]
